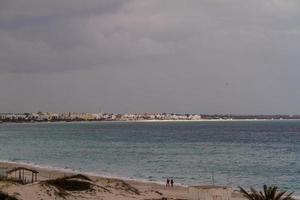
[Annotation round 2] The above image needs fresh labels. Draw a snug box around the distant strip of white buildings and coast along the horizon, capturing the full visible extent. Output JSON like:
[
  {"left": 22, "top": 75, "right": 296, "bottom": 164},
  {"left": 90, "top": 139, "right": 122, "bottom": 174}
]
[{"left": 0, "top": 112, "right": 300, "bottom": 123}]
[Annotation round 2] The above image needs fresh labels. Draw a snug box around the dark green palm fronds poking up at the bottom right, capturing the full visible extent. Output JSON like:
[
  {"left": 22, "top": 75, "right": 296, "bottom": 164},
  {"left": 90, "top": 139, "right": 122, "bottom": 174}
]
[{"left": 239, "top": 185, "right": 294, "bottom": 200}]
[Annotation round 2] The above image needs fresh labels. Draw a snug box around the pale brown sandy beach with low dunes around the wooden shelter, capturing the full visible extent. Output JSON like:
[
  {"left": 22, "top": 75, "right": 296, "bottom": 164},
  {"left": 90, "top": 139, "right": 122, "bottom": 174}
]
[{"left": 0, "top": 162, "right": 188, "bottom": 200}]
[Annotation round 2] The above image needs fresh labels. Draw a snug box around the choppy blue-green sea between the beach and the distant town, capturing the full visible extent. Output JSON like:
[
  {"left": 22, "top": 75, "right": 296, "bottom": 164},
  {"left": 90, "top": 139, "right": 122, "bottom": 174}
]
[{"left": 0, "top": 120, "right": 300, "bottom": 195}]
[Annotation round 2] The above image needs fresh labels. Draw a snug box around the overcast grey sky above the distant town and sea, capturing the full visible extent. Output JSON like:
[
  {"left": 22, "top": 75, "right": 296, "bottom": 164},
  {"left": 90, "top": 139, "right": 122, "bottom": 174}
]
[{"left": 0, "top": 0, "right": 300, "bottom": 114}]
